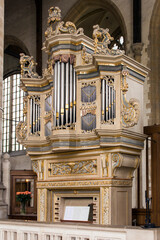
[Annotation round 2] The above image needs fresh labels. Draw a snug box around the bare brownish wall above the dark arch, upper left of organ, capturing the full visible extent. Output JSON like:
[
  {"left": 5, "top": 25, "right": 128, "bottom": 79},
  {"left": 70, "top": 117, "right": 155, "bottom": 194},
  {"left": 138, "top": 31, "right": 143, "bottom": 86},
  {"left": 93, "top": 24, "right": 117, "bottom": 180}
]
[{"left": 5, "top": 0, "right": 36, "bottom": 61}]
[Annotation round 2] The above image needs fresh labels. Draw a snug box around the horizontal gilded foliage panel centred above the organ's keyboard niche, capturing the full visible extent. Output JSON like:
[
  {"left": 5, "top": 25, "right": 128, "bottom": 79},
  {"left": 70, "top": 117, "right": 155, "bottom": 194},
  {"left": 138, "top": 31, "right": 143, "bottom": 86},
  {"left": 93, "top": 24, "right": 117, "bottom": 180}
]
[{"left": 48, "top": 160, "right": 97, "bottom": 176}]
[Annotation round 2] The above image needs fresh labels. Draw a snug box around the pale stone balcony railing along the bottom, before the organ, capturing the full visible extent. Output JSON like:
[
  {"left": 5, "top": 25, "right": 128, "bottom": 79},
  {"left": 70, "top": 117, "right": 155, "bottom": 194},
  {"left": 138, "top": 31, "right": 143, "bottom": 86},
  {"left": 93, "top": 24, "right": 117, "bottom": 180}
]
[{"left": 0, "top": 220, "right": 160, "bottom": 240}]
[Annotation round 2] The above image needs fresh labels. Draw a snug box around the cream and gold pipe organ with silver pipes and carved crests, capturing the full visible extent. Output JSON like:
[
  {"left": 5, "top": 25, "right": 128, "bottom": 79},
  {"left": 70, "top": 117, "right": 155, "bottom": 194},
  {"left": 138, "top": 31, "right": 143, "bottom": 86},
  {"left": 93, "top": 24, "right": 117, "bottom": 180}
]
[{"left": 16, "top": 7, "right": 148, "bottom": 225}]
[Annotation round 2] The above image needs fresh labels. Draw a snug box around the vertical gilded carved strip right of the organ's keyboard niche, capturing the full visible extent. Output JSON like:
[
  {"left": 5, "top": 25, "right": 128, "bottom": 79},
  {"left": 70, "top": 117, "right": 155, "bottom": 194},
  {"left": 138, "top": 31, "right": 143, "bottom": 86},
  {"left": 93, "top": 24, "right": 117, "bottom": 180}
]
[{"left": 102, "top": 187, "right": 110, "bottom": 224}]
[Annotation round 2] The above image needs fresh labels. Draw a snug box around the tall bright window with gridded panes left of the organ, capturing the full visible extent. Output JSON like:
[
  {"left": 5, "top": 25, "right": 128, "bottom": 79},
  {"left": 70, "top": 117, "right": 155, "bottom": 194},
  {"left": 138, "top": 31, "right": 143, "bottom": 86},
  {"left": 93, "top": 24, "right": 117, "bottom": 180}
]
[{"left": 2, "top": 74, "right": 23, "bottom": 152}]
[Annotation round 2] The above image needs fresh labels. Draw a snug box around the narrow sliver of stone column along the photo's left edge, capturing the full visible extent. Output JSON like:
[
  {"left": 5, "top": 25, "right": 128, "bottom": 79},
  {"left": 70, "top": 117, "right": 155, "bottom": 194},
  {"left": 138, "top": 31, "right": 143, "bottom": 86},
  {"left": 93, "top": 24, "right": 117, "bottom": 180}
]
[{"left": 0, "top": 0, "right": 7, "bottom": 218}]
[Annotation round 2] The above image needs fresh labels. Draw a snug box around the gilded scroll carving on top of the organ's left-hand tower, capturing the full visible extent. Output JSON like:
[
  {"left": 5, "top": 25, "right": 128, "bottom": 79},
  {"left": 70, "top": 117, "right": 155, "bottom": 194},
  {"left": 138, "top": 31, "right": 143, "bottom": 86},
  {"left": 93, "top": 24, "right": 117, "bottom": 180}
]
[{"left": 20, "top": 53, "right": 39, "bottom": 78}]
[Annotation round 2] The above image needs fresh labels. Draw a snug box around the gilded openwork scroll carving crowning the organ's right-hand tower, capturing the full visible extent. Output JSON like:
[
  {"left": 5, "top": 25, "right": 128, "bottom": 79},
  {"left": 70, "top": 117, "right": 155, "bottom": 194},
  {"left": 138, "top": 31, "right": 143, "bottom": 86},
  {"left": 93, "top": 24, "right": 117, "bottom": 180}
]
[{"left": 93, "top": 24, "right": 123, "bottom": 55}]
